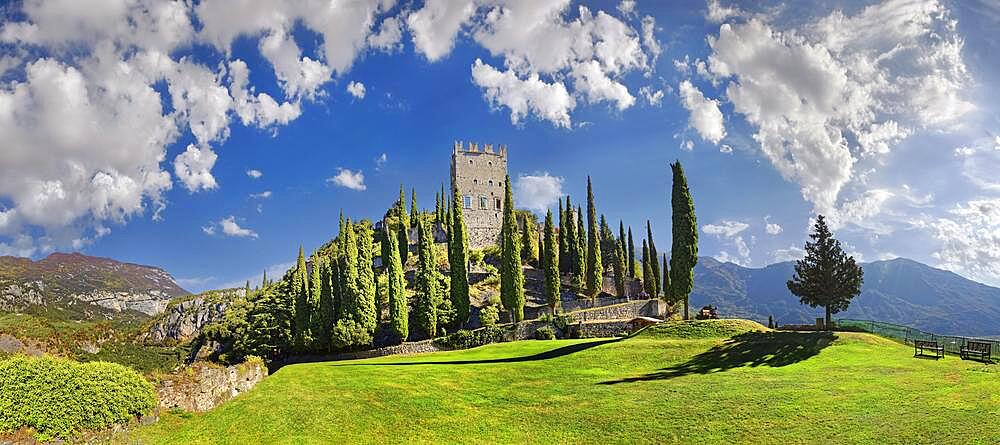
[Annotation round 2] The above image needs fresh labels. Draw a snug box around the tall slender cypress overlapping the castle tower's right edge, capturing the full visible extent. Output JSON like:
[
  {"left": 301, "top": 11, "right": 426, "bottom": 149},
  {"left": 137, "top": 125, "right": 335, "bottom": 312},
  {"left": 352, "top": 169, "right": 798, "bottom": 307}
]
[{"left": 500, "top": 175, "right": 524, "bottom": 322}]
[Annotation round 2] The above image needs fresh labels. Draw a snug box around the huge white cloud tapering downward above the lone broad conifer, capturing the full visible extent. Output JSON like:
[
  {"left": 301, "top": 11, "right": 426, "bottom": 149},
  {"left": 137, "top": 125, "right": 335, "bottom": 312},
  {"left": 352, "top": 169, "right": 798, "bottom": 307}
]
[{"left": 707, "top": 0, "right": 974, "bottom": 213}]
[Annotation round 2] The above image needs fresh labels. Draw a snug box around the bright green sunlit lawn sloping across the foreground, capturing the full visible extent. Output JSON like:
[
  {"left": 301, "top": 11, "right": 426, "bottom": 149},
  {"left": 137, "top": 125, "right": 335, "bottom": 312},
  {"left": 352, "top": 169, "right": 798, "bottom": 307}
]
[{"left": 127, "top": 321, "right": 1000, "bottom": 445}]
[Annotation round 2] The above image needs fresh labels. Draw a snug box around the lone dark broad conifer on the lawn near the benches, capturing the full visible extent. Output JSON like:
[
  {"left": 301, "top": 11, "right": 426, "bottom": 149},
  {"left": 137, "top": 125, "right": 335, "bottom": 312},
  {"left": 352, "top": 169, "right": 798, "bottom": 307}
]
[{"left": 787, "top": 215, "right": 864, "bottom": 329}]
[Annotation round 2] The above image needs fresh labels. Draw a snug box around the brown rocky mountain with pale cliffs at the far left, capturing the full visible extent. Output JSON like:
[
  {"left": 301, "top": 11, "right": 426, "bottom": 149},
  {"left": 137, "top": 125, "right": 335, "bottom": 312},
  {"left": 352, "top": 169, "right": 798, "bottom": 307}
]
[{"left": 0, "top": 253, "right": 189, "bottom": 319}]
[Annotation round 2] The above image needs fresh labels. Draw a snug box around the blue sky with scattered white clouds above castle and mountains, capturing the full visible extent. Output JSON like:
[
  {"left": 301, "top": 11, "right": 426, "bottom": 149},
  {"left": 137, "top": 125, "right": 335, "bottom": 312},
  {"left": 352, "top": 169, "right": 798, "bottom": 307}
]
[{"left": 0, "top": 0, "right": 1000, "bottom": 290}]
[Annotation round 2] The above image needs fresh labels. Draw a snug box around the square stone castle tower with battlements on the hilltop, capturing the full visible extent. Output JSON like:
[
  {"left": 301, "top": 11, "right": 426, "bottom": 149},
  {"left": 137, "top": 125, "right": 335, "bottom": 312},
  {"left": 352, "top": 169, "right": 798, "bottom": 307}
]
[{"left": 451, "top": 141, "right": 507, "bottom": 249}]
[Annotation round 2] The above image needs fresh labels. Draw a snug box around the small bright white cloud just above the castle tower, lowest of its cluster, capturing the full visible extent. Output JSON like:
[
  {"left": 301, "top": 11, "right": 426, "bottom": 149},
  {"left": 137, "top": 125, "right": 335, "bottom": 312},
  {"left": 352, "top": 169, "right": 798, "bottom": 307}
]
[{"left": 472, "top": 59, "right": 576, "bottom": 128}]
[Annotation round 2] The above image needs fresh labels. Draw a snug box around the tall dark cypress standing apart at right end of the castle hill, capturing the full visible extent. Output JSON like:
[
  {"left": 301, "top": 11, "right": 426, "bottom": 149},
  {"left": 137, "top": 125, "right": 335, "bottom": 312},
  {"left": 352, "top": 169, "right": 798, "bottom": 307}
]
[{"left": 670, "top": 161, "right": 698, "bottom": 319}]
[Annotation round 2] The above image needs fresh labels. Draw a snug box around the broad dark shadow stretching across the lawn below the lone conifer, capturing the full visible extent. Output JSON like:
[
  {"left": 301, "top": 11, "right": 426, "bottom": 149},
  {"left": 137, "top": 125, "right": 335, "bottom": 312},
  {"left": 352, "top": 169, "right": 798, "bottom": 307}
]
[{"left": 599, "top": 332, "right": 837, "bottom": 385}]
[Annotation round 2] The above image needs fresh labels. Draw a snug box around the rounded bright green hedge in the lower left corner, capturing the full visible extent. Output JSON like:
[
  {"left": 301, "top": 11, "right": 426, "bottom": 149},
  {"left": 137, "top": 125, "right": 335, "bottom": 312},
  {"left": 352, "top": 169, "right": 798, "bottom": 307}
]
[{"left": 0, "top": 355, "right": 156, "bottom": 441}]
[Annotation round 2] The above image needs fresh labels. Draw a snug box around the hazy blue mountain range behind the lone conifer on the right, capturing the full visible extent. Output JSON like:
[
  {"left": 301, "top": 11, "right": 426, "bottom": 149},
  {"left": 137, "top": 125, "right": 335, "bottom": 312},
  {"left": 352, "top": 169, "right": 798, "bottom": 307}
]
[{"left": 691, "top": 257, "right": 1000, "bottom": 336}]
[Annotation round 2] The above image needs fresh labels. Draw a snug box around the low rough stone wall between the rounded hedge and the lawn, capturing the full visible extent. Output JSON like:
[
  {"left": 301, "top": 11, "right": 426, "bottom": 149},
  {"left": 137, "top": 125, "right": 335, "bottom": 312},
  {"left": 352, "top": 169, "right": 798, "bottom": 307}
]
[{"left": 156, "top": 361, "right": 267, "bottom": 411}]
